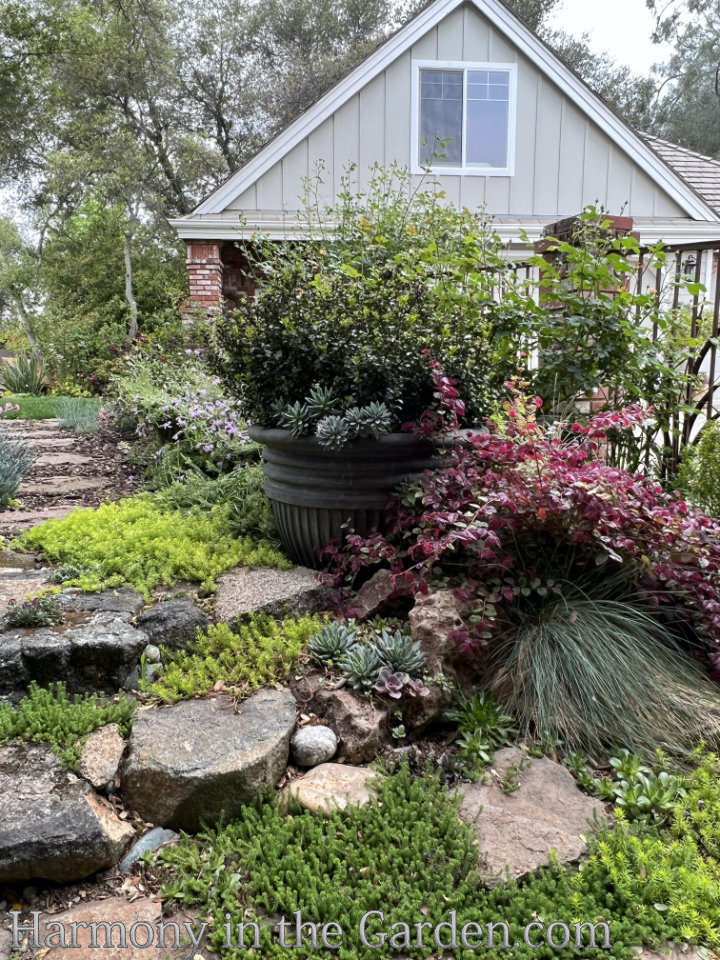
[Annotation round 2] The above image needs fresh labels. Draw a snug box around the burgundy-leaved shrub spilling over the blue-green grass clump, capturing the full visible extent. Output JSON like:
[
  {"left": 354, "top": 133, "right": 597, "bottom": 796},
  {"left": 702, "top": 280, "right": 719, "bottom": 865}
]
[{"left": 328, "top": 362, "right": 720, "bottom": 668}]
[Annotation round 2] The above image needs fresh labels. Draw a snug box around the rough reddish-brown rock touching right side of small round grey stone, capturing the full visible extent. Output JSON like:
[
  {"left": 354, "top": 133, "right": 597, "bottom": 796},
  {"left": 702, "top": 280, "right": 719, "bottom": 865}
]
[{"left": 307, "top": 687, "right": 388, "bottom": 763}]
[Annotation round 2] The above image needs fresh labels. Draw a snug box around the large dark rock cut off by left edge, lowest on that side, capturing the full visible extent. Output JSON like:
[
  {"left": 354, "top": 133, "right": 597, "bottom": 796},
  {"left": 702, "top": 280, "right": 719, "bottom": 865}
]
[{"left": 0, "top": 746, "right": 135, "bottom": 883}]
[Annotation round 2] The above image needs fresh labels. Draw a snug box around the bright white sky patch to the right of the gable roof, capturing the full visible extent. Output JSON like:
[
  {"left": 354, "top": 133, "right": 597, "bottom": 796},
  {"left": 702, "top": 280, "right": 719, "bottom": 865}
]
[{"left": 550, "top": 0, "right": 662, "bottom": 76}]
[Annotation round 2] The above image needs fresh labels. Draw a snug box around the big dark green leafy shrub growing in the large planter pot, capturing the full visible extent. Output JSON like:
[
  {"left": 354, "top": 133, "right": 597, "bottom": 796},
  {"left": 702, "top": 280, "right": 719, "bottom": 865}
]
[{"left": 216, "top": 169, "right": 516, "bottom": 438}]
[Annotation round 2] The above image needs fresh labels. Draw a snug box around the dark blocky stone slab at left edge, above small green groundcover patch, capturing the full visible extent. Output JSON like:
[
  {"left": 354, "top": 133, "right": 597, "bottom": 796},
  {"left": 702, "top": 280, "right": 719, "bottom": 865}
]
[{"left": 5, "top": 613, "right": 147, "bottom": 696}]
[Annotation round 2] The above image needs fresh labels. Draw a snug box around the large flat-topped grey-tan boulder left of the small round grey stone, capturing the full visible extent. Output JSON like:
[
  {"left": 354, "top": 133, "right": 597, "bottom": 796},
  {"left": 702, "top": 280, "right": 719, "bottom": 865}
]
[{"left": 122, "top": 690, "right": 295, "bottom": 830}]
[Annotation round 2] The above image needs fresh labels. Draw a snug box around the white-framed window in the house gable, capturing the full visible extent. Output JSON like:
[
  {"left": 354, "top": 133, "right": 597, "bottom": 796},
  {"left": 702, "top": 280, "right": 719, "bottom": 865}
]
[{"left": 412, "top": 60, "right": 517, "bottom": 177}]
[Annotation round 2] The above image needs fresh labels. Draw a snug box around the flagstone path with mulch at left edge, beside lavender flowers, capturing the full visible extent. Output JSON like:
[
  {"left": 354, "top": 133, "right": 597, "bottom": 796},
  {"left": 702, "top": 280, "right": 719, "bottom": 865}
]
[{"left": 0, "top": 420, "right": 135, "bottom": 540}]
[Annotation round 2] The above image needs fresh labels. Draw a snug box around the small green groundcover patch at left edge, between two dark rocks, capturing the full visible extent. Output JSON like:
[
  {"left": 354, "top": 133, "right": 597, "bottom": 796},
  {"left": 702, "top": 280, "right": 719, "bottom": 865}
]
[{"left": 0, "top": 684, "right": 135, "bottom": 770}]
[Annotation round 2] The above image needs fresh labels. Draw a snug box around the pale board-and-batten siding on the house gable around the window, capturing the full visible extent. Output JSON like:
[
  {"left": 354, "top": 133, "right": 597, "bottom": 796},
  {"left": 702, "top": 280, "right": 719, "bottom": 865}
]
[{"left": 227, "top": 4, "right": 687, "bottom": 219}]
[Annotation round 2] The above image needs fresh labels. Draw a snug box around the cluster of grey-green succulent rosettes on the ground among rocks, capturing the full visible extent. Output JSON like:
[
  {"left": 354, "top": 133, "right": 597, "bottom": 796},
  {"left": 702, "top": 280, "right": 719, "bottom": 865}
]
[{"left": 308, "top": 620, "right": 428, "bottom": 700}]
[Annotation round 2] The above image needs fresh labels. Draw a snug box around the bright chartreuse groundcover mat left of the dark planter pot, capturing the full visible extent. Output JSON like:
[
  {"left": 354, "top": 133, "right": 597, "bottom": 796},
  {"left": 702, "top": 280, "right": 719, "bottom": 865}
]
[{"left": 16, "top": 495, "right": 290, "bottom": 597}]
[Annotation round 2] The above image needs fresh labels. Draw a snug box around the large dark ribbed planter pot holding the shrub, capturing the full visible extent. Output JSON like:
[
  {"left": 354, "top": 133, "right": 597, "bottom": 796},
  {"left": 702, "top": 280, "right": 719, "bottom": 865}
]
[{"left": 249, "top": 427, "right": 437, "bottom": 568}]
